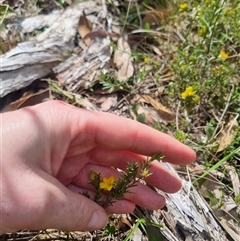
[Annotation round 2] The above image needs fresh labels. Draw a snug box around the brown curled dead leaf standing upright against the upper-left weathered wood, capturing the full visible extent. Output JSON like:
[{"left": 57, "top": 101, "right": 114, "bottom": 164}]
[{"left": 78, "top": 11, "right": 92, "bottom": 46}]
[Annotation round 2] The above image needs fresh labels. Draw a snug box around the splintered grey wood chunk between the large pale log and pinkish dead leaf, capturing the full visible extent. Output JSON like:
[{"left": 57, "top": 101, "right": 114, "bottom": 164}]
[{"left": 54, "top": 38, "right": 112, "bottom": 92}]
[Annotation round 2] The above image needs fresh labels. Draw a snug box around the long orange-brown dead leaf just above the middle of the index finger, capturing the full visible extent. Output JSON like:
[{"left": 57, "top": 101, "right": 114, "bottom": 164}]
[{"left": 142, "top": 95, "right": 176, "bottom": 122}]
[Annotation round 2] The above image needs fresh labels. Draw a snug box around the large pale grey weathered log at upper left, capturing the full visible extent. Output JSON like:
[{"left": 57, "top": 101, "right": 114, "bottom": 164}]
[{"left": 0, "top": 1, "right": 105, "bottom": 98}]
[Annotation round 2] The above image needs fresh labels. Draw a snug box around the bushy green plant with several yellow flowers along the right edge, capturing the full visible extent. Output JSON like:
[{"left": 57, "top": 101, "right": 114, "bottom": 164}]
[{"left": 167, "top": 0, "right": 240, "bottom": 159}]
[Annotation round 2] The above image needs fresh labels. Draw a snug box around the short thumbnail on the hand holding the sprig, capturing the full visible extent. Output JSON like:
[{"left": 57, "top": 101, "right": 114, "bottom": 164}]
[{"left": 86, "top": 210, "right": 107, "bottom": 231}]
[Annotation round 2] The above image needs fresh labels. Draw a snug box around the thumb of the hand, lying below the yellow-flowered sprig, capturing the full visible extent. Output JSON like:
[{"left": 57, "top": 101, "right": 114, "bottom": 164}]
[{"left": 38, "top": 185, "right": 107, "bottom": 231}]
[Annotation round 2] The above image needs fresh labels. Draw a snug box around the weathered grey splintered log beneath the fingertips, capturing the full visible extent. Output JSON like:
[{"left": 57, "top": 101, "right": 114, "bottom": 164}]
[{"left": 151, "top": 163, "right": 230, "bottom": 241}]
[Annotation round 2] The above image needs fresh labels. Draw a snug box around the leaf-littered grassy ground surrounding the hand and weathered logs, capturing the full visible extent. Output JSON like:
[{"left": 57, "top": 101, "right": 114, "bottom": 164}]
[{"left": 0, "top": 0, "right": 240, "bottom": 240}]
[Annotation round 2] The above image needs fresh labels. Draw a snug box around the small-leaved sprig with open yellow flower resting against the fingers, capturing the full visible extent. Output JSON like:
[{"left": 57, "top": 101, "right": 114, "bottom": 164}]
[{"left": 83, "top": 153, "right": 163, "bottom": 208}]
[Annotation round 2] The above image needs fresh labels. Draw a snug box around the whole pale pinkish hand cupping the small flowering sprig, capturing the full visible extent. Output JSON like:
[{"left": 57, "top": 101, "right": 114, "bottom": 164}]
[{"left": 0, "top": 101, "right": 196, "bottom": 233}]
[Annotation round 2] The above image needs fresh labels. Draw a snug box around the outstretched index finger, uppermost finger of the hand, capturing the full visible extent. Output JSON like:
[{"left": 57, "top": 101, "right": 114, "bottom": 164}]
[{"left": 69, "top": 107, "right": 196, "bottom": 164}]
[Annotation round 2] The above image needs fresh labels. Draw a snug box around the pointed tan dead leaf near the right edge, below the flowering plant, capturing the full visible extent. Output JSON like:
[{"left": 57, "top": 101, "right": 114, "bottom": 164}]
[{"left": 216, "top": 118, "right": 238, "bottom": 152}]
